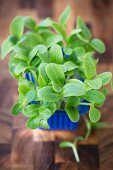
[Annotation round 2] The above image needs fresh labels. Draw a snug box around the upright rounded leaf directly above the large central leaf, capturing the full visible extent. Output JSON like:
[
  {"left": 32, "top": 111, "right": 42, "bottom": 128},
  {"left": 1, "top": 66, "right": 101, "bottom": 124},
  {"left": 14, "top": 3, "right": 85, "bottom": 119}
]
[{"left": 49, "top": 44, "right": 63, "bottom": 64}]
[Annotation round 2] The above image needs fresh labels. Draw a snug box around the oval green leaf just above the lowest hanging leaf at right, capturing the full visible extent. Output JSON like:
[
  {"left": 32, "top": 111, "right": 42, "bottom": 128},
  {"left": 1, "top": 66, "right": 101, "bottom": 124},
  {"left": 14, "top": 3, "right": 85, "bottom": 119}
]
[{"left": 84, "top": 90, "right": 105, "bottom": 105}]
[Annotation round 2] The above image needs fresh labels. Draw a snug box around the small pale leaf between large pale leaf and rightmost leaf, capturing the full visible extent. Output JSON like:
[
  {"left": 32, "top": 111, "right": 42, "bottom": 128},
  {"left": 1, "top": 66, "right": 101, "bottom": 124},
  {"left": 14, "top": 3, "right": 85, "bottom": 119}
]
[{"left": 84, "top": 78, "right": 102, "bottom": 90}]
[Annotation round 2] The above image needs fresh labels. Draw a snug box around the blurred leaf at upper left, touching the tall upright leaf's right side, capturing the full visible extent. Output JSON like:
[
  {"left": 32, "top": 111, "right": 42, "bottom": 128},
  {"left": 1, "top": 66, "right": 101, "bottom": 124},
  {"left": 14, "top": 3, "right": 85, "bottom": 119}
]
[{"left": 23, "top": 16, "right": 37, "bottom": 30}]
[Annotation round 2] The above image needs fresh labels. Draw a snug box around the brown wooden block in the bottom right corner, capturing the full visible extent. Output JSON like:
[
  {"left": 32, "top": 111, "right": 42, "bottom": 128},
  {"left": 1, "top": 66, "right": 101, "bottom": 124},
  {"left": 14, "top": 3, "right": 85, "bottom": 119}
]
[{"left": 97, "top": 128, "right": 113, "bottom": 170}]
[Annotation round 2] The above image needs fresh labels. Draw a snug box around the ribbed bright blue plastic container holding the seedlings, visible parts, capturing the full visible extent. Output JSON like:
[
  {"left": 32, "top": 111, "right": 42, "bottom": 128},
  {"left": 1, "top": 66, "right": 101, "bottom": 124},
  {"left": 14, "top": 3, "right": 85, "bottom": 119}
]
[{"left": 25, "top": 73, "right": 89, "bottom": 130}]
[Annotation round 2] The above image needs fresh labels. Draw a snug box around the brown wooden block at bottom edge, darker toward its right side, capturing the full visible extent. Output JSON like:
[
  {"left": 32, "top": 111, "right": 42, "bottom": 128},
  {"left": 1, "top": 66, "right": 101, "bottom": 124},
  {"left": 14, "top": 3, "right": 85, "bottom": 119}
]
[{"left": 33, "top": 142, "right": 55, "bottom": 170}]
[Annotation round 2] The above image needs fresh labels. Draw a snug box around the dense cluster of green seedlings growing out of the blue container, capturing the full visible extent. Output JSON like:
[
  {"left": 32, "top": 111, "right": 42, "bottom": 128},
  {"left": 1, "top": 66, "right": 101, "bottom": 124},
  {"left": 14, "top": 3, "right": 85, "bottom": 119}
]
[{"left": 1, "top": 7, "right": 112, "bottom": 129}]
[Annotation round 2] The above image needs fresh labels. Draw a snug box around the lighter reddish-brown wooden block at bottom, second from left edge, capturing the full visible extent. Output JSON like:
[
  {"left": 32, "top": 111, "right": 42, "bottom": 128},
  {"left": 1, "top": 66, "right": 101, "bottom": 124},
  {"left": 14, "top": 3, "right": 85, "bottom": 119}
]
[{"left": 11, "top": 129, "right": 33, "bottom": 170}]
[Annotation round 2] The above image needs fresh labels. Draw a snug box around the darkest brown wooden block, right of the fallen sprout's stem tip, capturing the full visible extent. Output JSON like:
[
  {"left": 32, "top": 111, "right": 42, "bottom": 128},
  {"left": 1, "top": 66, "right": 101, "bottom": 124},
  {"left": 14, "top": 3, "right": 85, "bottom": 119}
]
[{"left": 78, "top": 144, "right": 99, "bottom": 170}]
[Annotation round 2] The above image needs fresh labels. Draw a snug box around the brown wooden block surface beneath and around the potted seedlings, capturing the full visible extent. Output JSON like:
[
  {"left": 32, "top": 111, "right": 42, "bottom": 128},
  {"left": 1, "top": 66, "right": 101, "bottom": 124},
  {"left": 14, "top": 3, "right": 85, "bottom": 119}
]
[{"left": 0, "top": 0, "right": 113, "bottom": 170}]
